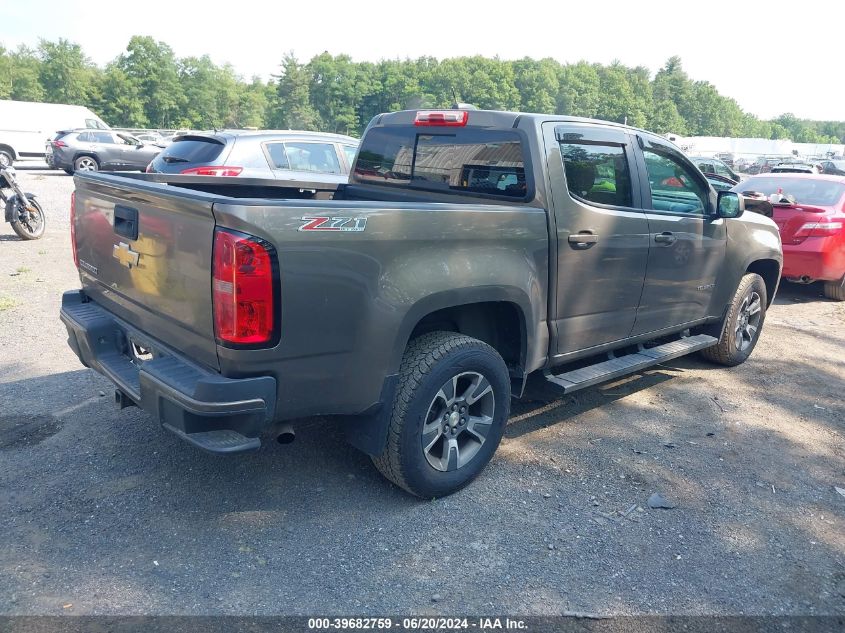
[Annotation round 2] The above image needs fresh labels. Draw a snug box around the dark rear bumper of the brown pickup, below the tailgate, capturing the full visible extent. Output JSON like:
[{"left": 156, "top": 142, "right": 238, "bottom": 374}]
[{"left": 61, "top": 290, "right": 276, "bottom": 453}]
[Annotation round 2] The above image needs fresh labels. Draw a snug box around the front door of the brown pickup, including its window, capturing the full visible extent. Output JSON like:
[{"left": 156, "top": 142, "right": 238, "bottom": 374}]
[{"left": 632, "top": 136, "right": 727, "bottom": 335}]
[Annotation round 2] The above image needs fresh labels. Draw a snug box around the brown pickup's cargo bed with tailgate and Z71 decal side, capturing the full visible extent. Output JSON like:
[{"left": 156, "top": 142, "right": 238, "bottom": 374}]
[{"left": 69, "top": 173, "right": 548, "bottom": 417}]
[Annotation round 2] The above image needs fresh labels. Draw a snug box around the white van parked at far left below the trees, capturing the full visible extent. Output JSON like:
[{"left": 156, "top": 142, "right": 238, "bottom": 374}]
[{"left": 0, "top": 99, "right": 111, "bottom": 166}]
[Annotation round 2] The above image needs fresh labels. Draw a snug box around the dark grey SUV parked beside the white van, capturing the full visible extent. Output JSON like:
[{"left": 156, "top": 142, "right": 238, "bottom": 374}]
[{"left": 46, "top": 130, "right": 161, "bottom": 174}]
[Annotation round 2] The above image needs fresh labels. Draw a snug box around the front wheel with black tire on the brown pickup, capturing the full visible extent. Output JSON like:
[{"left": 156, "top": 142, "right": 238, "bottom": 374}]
[{"left": 700, "top": 273, "right": 767, "bottom": 367}]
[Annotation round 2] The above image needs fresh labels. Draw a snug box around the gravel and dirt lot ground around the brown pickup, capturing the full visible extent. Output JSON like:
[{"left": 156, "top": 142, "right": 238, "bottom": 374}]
[{"left": 0, "top": 169, "right": 845, "bottom": 615}]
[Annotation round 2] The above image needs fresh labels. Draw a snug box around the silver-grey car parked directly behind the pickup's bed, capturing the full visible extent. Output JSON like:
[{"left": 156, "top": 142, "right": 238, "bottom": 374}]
[{"left": 147, "top": 130, "right": 358, "bottom": 183}]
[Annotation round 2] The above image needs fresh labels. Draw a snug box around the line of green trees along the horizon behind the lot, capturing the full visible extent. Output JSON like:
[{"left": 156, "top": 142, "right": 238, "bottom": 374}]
[{"left": 0, "top": 36, "right": 845, "bottom": 143}]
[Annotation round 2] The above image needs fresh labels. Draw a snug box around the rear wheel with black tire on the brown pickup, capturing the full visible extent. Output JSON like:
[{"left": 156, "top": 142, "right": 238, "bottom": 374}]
[{"left": 373, "top": 332, "right": 510, "bottom": 498}]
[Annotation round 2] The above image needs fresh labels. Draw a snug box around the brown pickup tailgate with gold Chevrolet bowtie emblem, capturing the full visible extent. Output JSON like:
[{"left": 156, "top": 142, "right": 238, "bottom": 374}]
[{"left": 72, "top": 174, "right": 218, "bottom": 369}]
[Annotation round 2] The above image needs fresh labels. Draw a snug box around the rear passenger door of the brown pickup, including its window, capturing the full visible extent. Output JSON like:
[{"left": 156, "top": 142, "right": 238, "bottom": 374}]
[{"left": 543, "top": 122, "right": 649, "bottom": 357}]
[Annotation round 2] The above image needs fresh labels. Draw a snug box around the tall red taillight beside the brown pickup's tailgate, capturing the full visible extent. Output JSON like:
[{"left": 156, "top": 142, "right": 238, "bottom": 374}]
[{"left": 212, "top": 229, "right": 277, "bottom": 345}]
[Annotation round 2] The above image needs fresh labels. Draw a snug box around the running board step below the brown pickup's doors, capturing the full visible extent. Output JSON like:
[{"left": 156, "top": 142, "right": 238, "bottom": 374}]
[{"left": 546, "top": 334, "right": 718, "bottom": 393}]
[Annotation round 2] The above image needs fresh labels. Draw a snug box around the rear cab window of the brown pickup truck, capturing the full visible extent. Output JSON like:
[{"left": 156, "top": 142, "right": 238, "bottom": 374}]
[{"left": 350, "top": 125, "right": 532, "bottom": 200}]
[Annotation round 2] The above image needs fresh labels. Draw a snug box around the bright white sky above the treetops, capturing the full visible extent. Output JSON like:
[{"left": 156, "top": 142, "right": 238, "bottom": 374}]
[{"left": 0, "top": 0, "right": 845, "bottom": 120}]
